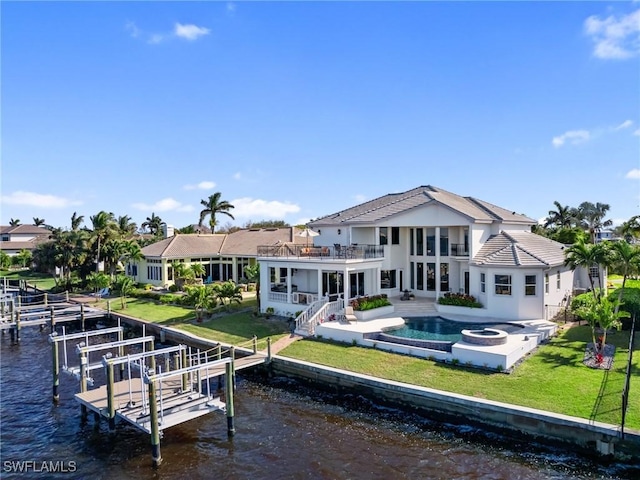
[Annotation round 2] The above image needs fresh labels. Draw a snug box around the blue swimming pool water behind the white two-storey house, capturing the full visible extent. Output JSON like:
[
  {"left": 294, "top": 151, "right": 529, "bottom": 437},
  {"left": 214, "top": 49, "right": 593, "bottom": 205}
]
[{"left": 385, "top": 317, "right": 522, "bottom": 343}]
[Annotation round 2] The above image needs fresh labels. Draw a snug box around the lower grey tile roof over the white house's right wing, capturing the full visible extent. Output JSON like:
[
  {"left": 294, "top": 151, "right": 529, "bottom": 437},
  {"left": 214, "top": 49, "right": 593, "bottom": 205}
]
[{"left": 471, "top": 231, "right": 565, "bottom": 267}]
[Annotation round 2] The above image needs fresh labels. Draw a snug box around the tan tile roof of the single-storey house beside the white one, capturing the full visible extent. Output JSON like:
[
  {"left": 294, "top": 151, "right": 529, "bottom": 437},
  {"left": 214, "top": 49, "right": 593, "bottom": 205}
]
[{"left": 142, "top": 227, "right": 303, "bottom": 258}]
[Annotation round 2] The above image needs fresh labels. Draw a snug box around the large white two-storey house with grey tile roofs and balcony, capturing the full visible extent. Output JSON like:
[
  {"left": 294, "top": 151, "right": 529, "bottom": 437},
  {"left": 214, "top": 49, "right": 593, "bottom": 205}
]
[{"left": 258, "top": 186, "right": 596, "bottom": 320}]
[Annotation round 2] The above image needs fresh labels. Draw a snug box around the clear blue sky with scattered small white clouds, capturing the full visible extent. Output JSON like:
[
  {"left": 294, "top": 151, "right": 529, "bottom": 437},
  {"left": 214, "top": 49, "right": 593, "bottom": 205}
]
[{"left": 0, "top": 2, "right": 640, "bottom": 231}]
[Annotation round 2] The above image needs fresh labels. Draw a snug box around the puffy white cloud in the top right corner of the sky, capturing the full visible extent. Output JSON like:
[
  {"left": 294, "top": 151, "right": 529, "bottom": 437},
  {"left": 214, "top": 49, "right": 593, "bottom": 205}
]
[{"left": 584, "top": 9, "right": 640, "bottom": 59}]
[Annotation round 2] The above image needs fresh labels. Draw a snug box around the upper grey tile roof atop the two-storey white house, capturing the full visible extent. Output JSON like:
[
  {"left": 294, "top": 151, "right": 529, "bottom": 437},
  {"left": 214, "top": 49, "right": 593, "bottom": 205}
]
[{"left": 309, "top": 185, "right": 536, "bottom": 227}]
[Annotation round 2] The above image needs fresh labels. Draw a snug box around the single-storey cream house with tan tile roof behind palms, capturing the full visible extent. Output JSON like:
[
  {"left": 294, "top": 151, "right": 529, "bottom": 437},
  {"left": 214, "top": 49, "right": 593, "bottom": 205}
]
[{"left": 132, "top": 227, "right": 301, "bottom": 287}]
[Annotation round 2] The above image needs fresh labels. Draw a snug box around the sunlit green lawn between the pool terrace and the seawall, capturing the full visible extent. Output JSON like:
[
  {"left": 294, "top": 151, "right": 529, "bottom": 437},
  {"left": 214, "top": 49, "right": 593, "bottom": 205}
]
[{"left": 279, "top": 326, "right": 640, "bottom": 429}]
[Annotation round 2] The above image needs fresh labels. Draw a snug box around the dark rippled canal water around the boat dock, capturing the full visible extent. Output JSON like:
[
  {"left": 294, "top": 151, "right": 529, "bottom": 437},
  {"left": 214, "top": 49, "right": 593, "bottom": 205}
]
[{"left": 0, "top": 328, "right": 640, "bottom": 480}]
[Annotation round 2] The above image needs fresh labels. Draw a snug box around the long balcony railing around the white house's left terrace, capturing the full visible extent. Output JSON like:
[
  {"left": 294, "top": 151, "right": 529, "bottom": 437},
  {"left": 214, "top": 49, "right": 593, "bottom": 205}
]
[{"left": 258, "top": 244, "right": 384, "bottom": 260}]
